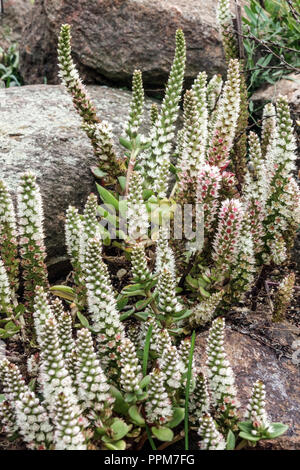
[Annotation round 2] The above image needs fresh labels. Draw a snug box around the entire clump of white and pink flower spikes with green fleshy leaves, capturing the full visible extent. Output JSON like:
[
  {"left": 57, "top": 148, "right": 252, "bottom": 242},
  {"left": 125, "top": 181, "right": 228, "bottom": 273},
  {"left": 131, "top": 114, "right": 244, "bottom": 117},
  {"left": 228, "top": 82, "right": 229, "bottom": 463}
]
[{"left": 0, "top": 0, "right": 299, "bottom": 450}]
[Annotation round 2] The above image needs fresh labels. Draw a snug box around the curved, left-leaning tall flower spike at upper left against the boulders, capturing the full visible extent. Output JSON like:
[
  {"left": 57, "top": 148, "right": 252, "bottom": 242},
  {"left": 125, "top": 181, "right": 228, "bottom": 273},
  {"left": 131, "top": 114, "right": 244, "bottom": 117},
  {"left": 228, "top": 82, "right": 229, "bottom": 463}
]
[{"left": 57, "top": 24, "right": 99, "bottom": 124}]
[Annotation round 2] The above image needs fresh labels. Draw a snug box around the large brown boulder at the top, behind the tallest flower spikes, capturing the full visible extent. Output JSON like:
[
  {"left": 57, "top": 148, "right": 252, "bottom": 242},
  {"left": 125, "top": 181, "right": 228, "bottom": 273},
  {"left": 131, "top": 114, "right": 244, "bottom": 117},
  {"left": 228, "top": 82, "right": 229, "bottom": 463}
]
[{"left": 21, "top": 0, "right": 247, "bottom": 89}]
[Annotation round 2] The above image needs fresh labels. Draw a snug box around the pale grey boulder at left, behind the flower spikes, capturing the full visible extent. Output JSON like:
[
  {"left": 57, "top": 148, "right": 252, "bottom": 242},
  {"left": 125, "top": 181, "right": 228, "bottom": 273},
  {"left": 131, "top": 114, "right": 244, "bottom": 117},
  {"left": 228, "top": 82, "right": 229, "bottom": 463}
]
[{"left": 0, "top": 85, "right": 155, "bottom": 278}]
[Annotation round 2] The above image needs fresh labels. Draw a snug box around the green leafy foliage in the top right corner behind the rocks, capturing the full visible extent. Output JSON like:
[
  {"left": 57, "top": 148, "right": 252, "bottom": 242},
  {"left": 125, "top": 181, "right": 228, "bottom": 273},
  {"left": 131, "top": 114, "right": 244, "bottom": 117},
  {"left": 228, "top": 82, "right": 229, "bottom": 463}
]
[{"left": 242, "top": 0, "right": 300, "bottom": 93}]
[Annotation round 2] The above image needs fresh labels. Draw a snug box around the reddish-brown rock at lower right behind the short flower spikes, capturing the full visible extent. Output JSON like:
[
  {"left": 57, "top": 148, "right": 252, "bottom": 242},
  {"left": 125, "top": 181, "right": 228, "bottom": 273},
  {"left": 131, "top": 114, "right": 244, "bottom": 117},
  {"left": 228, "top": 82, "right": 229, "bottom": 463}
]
[{"left": 195, "top": 327, "right": 300, "bottom": 450}]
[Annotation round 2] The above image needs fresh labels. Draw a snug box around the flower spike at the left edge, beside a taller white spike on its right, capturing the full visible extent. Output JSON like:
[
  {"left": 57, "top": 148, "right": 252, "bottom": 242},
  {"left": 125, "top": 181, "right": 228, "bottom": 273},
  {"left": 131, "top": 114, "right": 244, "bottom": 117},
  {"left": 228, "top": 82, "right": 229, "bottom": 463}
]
[{"left": 0, "top": 180, "right": 20, "bottom": 292}]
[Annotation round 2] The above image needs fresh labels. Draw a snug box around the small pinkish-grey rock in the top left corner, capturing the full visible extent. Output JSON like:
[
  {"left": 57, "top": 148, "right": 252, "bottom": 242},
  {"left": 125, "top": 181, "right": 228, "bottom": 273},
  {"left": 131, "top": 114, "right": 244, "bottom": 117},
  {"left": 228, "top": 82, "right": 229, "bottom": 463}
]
[{"left": 0, "top": 0, "right": 33, "bottom": 49}]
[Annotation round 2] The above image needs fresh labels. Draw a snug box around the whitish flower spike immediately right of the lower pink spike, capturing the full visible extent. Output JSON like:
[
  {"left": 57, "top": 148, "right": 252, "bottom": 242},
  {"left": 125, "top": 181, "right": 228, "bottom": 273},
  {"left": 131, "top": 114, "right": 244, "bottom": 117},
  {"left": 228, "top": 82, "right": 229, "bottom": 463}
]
[{"left": 229, "top": 213, "right": 256, "bottom": 304}]
